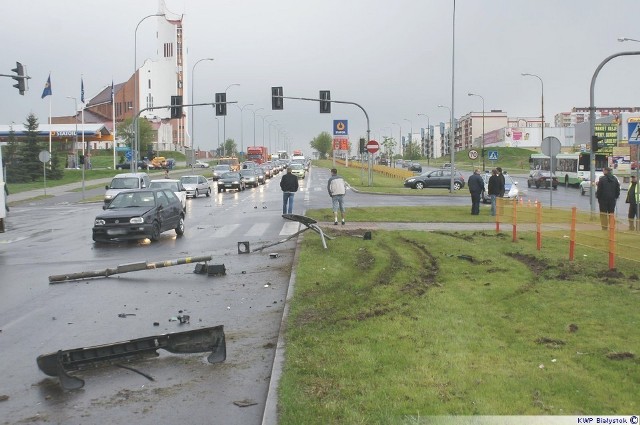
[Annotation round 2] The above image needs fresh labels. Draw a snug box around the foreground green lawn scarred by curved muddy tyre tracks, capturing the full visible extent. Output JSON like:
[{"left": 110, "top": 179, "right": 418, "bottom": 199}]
[{"left": 279, "top": 227, "right": 640, "bottom": 424}]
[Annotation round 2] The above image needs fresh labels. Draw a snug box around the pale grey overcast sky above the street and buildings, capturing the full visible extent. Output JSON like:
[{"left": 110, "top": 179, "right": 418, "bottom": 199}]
[{"left": 0, "top": 0, "right": 640, "bottom": 153}]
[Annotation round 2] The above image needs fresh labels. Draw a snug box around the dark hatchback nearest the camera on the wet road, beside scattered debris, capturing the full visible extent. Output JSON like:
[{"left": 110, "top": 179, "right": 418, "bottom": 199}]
[{"left": 93, "top": 189, "right": 184, "bottom": 242}]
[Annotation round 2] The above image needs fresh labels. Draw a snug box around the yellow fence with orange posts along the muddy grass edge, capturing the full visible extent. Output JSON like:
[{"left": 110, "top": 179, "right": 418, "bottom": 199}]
[{"left": 496, "top": 198, "right": 640, "bottom": 270}]
